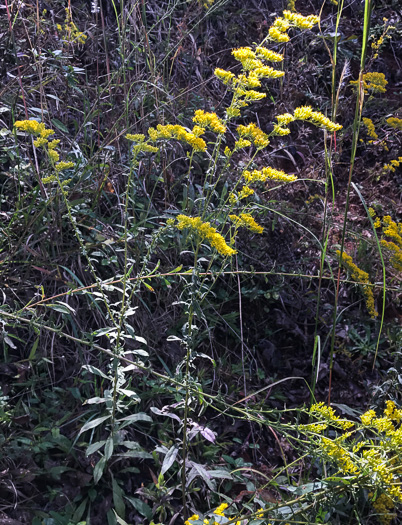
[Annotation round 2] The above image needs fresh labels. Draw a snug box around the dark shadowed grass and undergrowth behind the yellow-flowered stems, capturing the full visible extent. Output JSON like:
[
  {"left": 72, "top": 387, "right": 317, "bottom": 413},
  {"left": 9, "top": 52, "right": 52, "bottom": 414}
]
[{"left": 0, "top": 0, "right": 402, "bottom": 525}]
